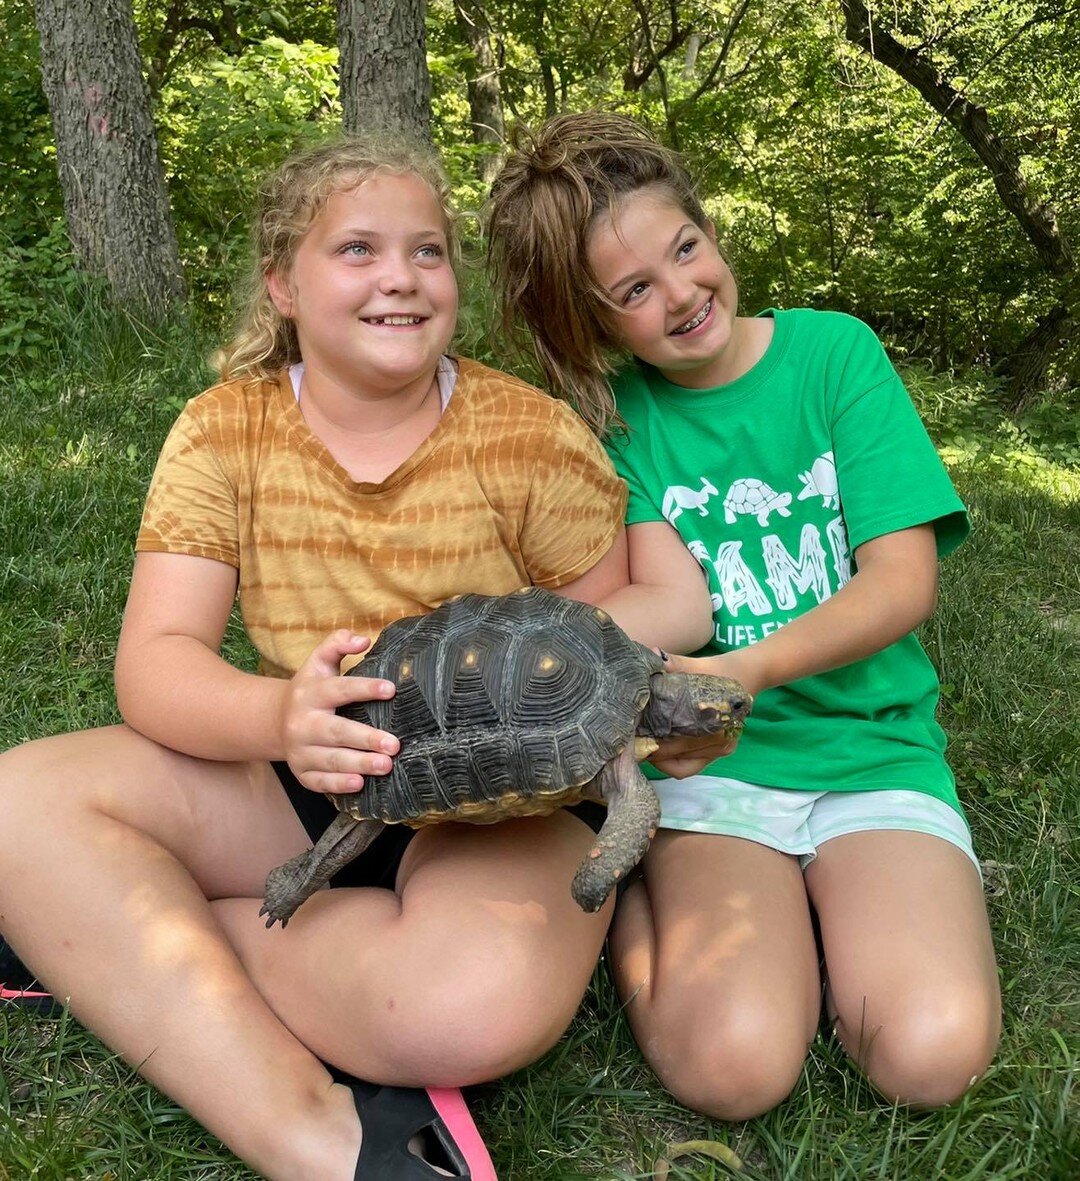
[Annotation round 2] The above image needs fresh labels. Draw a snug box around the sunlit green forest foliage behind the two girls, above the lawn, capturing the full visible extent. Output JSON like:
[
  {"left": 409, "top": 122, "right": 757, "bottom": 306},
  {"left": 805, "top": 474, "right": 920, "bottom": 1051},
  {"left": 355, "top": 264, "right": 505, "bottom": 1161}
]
[{"left": 0, "top": 0, "right": 1080, "bottom": 406}]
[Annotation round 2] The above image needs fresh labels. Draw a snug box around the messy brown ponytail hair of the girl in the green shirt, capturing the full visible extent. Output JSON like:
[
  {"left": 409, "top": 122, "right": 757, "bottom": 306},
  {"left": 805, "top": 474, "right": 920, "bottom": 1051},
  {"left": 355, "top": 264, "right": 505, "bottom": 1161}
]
[{"left": 487, "top": 110, "right": 708, "bottom": 436}]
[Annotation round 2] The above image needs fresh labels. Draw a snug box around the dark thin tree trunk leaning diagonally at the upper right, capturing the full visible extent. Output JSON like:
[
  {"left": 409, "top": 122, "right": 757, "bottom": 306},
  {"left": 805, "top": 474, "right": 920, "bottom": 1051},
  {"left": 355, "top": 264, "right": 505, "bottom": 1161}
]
[{"left": 840, "top": 0, "right": 1080, "bottom": 412}]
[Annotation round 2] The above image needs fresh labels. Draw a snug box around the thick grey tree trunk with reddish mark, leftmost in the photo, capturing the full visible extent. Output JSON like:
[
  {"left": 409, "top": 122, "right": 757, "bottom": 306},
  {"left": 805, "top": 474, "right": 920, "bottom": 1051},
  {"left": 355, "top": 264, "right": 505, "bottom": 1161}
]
[{"left": 34, "top": 0, "right": 184, "bottom": 311}]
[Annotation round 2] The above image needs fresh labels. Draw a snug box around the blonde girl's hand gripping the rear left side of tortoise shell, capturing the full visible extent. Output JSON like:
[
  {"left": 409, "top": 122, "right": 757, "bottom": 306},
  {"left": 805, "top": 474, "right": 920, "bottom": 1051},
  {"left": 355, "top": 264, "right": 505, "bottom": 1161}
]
[{"left": 281, "top": 629, "right": 401, "bottom": 794}]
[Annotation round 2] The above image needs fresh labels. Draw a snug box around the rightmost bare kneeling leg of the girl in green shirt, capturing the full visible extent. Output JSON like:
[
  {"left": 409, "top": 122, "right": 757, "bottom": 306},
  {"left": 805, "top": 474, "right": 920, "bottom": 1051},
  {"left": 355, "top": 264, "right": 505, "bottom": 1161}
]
[{"left": 806, "top": 831, "right": 1001, "bottom": 1107}]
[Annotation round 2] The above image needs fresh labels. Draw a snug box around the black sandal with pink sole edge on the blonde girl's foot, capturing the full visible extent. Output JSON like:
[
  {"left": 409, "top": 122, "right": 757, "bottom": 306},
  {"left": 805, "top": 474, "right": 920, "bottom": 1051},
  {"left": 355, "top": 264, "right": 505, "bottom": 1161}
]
[{"left": 333, "top": 1071, "right": 497, "bottom": 1181}]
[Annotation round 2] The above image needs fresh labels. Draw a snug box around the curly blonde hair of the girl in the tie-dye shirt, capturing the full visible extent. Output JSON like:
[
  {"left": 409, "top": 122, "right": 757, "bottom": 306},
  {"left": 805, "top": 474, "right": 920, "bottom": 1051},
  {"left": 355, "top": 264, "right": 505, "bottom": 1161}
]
[{"left": 210, "top": 136, "right": 457, "bottom": 381}]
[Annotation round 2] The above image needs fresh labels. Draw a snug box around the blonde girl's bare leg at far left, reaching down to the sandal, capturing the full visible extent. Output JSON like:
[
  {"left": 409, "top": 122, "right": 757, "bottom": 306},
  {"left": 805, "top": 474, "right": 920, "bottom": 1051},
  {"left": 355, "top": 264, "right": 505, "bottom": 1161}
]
[{"left": 0, "top": 727, "right": 358, "bottom": 1179}]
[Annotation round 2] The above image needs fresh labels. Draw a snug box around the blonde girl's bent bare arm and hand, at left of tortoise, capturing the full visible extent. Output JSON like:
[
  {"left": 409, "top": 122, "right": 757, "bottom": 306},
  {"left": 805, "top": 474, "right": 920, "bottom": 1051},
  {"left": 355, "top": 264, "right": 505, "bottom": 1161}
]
[{"left": 116, "top": 553, "right": 397, "bottom": 791}]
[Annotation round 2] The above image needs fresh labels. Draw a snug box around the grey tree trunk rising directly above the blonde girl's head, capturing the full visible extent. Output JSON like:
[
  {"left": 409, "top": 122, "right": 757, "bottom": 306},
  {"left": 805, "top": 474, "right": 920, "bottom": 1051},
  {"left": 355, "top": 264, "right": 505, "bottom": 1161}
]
[{"left": 337, "top": 0, "right": 431, "bottom": 139}]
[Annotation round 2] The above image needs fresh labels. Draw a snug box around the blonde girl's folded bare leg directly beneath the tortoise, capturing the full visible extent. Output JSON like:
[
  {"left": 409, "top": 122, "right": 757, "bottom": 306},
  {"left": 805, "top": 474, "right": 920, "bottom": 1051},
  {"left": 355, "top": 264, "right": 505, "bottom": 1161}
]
[{"left": 214, "top": 813, "right": 612, "bottom": 1087}]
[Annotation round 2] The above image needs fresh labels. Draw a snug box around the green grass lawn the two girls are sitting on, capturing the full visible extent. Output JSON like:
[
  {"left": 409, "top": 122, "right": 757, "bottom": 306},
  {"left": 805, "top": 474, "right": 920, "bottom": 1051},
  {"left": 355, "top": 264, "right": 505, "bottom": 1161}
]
[{"left": 0, "top": 302, "right": 1080, "bottom": 1181}]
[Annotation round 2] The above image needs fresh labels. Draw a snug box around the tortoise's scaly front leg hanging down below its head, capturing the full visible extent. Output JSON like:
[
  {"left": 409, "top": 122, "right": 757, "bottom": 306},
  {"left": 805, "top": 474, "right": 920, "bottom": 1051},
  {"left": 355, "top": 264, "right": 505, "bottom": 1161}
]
[{"left": 570, "top": 742, "right": 661, "bottom": 914}]
